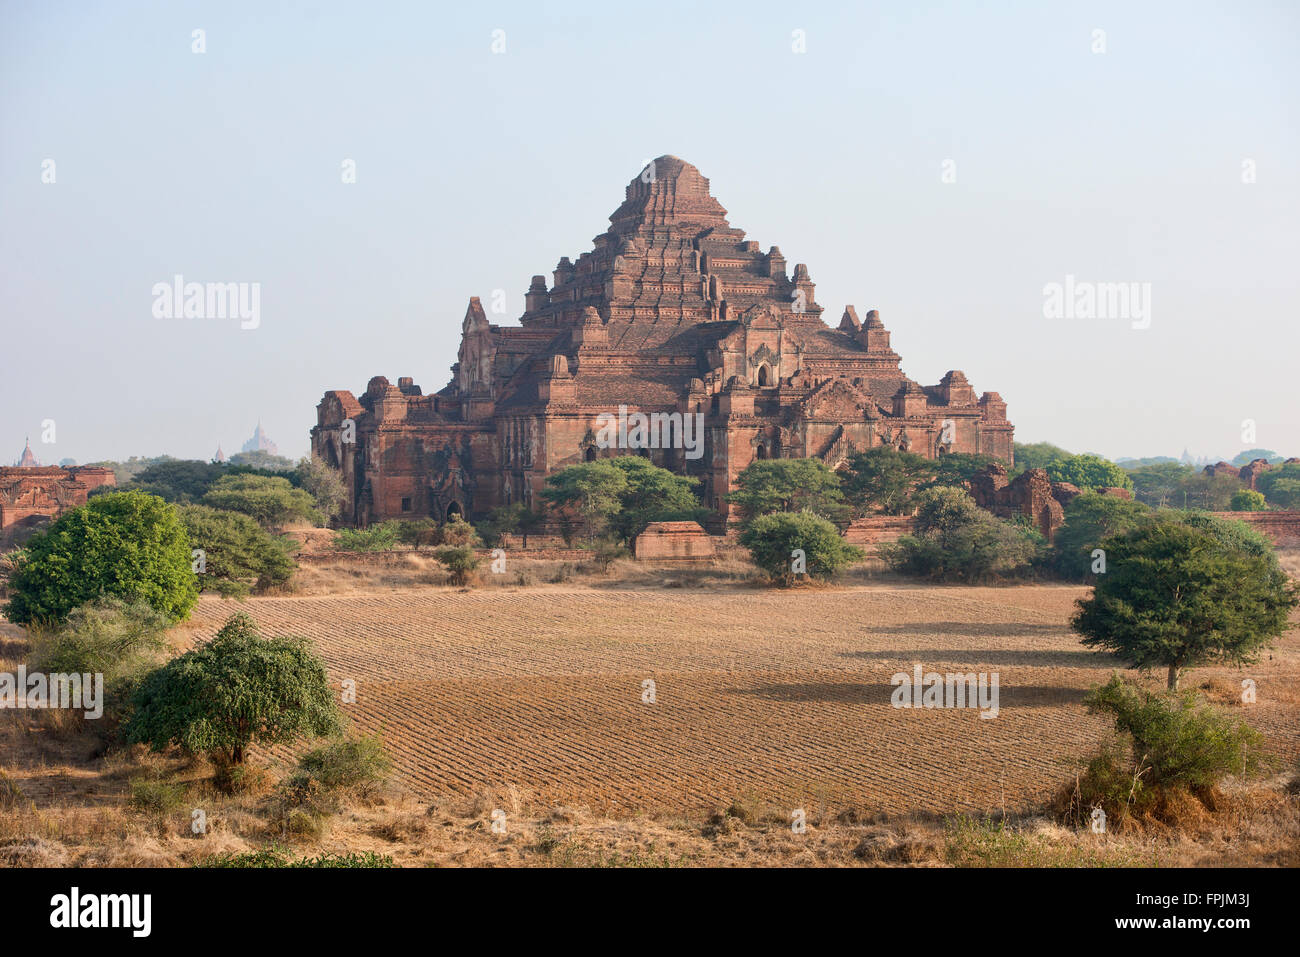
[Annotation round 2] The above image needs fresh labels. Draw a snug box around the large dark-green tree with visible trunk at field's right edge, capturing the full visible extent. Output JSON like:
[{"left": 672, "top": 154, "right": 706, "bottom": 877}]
[{"left": 1071, "top": 515, "right": 1300, "bottom": 689}]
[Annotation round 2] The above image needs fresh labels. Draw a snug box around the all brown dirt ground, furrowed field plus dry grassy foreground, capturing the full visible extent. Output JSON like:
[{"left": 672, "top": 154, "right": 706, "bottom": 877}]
[{"left": 0, "top": 570, "right": 1300, "bottom": 866}]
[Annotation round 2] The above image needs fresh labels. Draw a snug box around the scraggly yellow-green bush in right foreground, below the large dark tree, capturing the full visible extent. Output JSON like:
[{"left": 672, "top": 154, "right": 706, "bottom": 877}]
[{"left": 1057, "top": 675, "right": 1264, "bottom": 823}]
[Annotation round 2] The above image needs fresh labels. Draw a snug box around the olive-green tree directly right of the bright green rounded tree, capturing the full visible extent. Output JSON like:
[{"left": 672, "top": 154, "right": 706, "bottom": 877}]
[{"left": 177, "top": 505, "right": 296, "bottom": 598}]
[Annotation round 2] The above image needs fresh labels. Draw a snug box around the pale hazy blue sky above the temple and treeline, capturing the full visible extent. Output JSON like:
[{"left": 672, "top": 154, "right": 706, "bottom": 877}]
[{"left": 0, "top": 0, "right": 1300, "bottom": 464}]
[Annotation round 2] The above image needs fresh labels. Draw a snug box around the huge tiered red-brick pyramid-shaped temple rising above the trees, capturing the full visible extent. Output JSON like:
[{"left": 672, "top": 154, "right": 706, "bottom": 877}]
[{"left": 311, "top": 156, "right": 1013, "bottom": 531}]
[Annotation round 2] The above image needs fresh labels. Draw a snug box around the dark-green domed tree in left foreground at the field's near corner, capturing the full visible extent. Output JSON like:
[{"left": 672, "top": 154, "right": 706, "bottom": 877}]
[{"left": 124, "top": 612, "right": 342, "bottom": 765}]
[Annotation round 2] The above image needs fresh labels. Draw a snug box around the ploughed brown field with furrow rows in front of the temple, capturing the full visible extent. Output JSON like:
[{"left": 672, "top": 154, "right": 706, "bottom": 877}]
[{"left": 172, "top": 585, "right": 1300, "bottom": 818}]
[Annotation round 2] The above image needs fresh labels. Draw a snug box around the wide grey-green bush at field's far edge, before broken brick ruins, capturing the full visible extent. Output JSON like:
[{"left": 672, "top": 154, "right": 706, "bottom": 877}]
[{"left": 878, "top": 488, "right": 1044, "bottom": 581}]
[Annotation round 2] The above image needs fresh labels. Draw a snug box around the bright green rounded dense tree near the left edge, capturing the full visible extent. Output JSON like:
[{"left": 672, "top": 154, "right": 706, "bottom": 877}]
[{"left": 5, "top": 492, "right": 199, "bottom": 624}]
